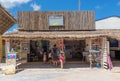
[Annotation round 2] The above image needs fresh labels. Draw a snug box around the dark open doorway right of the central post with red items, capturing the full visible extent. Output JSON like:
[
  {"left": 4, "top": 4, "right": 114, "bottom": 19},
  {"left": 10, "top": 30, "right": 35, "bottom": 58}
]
[{"left": 64, "top": 40, "right": 85, "bottom": 61}]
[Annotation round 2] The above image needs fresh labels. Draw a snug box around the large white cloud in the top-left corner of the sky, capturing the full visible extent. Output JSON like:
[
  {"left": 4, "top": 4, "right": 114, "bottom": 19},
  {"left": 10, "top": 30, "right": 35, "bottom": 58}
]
[{"left": 0, "top": 0, "right": 31, "bottom": 9}]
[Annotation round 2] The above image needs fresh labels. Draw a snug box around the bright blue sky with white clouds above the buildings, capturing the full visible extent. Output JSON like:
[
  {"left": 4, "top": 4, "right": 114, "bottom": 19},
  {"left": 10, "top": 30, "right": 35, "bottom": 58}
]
[{"left": 0, "top": 0, "right": 120, "bottom": 31}]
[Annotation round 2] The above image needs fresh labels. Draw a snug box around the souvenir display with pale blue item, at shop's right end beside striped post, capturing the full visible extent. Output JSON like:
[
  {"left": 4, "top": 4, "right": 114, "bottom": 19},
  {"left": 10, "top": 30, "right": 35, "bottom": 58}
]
[{"left": 88, "top": 38, "right": 102, "bottom": 68}]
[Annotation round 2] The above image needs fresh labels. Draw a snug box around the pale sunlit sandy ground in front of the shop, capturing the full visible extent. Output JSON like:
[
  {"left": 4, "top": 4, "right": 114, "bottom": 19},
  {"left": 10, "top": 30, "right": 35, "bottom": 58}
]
[{"left": 0, "top": 62, "right": 120, "bottom": 81}]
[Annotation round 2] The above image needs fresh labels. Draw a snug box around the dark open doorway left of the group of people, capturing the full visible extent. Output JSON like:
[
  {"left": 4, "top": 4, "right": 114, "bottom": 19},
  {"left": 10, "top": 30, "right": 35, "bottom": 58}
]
[{"left": 28, "top": 40, "right": 49, "bottom": 62}]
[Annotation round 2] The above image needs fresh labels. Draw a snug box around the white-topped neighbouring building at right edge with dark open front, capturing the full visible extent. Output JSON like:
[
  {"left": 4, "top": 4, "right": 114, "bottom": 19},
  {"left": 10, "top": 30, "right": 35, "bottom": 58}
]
[{"left": 95, "top": 16, "right": 120, "bottom": 60}]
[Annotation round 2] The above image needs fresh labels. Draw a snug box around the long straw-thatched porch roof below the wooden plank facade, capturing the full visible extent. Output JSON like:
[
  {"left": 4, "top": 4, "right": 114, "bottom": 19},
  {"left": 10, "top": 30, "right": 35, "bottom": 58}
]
[{"left": 2, "top": 30, "right": 117, "bottom": 39}]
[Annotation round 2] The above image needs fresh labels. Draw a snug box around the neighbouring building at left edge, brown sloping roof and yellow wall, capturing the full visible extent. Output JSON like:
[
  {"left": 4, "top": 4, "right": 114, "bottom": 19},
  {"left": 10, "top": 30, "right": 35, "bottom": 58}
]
[{"left": 0, "top": 5, "right": 16, "bottom": 61}]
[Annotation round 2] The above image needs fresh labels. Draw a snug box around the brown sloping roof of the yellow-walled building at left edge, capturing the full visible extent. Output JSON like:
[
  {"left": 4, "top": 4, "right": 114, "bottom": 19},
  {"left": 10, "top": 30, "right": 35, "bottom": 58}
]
[{"left": 0, "top": 5, "right": 16, "bottom": 34}]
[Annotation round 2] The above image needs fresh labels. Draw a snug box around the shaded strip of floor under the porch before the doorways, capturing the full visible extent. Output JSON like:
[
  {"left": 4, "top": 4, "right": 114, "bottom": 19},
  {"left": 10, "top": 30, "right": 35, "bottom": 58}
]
[{"left": 18, "top": 62, "right": 89, "bottom": 69}]
